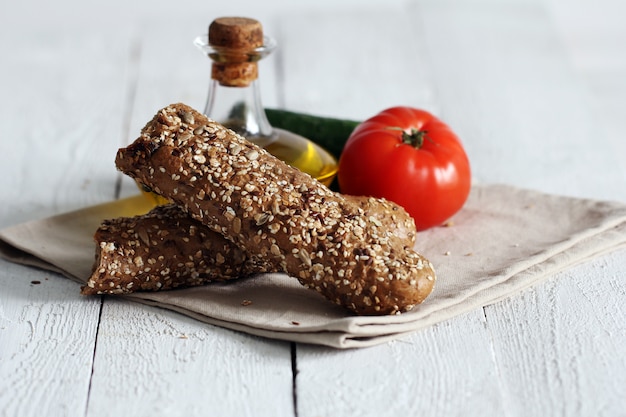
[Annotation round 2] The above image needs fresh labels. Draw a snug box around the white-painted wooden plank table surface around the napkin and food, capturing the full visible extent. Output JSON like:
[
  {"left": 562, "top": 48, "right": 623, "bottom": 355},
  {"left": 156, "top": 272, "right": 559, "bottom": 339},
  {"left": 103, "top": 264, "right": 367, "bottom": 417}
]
[{"left": 0, "top": 0, "right": 626, "bottom": 417}]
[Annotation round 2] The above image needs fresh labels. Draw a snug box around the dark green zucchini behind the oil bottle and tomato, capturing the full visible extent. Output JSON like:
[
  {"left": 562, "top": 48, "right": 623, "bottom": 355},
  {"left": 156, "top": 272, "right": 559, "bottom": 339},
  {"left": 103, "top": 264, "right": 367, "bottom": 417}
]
[{"left": 265, "top": 109, "right": 360, "bottom": 160}]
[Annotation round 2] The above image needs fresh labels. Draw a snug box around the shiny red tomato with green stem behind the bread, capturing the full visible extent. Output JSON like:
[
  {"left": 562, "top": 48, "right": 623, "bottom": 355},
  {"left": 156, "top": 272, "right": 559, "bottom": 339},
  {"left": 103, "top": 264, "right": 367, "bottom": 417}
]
[{"left": 338, "top": 107, "right": 471, "bottom": 230}]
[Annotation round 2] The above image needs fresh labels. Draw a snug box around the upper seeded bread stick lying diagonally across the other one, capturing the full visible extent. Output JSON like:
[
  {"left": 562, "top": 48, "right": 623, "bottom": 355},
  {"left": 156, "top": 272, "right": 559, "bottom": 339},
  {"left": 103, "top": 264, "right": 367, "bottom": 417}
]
[{"left": 116, "top": 104, "right": 435, "bottom": 315}]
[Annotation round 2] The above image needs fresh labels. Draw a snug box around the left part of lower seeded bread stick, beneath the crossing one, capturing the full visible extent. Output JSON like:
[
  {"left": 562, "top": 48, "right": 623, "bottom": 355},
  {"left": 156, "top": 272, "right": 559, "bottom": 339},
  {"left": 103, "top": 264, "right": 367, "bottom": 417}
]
[{"left": 81, "top": 205, "right": 271, "bottom": 295}]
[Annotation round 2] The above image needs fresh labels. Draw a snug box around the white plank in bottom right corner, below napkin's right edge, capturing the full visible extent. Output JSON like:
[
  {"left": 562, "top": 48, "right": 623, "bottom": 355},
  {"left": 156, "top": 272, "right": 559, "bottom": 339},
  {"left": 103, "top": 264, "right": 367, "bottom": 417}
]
[{"left": 486, "top": 250, "right": 626, "bottom": 416}]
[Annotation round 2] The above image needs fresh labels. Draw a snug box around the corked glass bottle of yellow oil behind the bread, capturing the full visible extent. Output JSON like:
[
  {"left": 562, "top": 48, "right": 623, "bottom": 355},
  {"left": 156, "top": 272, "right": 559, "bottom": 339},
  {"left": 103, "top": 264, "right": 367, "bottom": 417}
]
[{"left": 195, "top": 17, "right": 337, "bottom": 185}]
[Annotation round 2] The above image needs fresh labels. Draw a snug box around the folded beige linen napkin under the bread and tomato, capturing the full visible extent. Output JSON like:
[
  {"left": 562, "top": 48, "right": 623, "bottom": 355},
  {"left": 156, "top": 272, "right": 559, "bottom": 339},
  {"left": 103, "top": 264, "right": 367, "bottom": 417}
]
[{"left": 0, "top": 185, "right": 626, "bottom": 348}]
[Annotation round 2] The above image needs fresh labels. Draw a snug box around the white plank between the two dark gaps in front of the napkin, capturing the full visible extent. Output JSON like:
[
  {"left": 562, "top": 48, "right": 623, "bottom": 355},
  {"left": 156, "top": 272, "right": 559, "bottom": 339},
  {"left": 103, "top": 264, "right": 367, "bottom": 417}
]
[{"left": 87, "top": 299, "right": 293, "bottom": 416}]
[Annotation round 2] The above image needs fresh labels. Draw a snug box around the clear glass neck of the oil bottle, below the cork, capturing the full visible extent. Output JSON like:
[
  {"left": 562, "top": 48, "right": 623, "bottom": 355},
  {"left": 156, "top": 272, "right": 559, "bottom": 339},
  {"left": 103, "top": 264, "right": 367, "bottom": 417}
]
[{"left": 204, "top": 78, "right": 274, "bottom": 146}]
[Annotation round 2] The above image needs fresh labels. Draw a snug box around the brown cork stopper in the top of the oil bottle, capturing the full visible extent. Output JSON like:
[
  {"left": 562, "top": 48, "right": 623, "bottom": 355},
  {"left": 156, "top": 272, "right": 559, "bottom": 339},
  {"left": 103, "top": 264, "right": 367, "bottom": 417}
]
[{"left": 209, "top": 17, "right": 263, "bottom": 87}]
